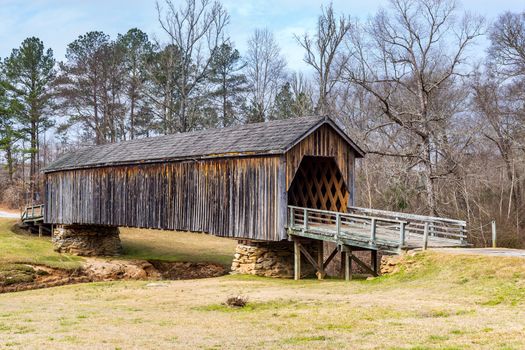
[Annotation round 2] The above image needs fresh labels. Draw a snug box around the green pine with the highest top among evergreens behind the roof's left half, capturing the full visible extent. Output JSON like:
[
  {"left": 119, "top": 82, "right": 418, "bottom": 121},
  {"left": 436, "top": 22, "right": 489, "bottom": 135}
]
[{"left": 116, "top": 28, "right": 153, "bottom": 140}]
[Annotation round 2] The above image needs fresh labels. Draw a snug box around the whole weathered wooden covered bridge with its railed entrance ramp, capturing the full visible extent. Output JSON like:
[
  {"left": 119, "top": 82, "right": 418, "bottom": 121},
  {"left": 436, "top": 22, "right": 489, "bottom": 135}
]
[{"left": 44, "top": 117, "right": 466, "bottom": 278}]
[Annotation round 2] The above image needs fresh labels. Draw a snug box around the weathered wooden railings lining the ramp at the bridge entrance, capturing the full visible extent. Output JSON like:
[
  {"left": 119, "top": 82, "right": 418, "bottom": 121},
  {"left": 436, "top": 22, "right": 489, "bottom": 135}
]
[{"left": 288, "top": 206, "right": 466, "bottom": 250}]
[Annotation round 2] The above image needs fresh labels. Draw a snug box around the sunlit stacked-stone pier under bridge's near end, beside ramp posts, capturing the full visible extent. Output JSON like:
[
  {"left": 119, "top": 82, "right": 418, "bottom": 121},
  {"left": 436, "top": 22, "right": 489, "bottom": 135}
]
[{"left": 231, "top": 241, "right": 319, "bottom": 278}]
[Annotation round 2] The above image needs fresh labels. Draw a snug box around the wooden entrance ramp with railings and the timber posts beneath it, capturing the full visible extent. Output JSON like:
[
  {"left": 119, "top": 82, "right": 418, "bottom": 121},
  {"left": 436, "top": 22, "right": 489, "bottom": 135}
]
[{"left": 287, "top": 206, "right": 468, "bottom": 280}]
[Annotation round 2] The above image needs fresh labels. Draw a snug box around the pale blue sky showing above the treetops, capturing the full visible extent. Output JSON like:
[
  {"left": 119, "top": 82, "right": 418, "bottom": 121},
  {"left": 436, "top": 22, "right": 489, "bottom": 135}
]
[{"left": 0, "top": 0, "right": 525, "bottom": 69}]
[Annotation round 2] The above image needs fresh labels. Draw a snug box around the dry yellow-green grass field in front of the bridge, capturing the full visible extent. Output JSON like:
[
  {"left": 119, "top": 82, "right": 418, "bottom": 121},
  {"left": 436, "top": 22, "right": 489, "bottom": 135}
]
[{"left": 0, "top": 217, "right": 525, "bottom": 349}]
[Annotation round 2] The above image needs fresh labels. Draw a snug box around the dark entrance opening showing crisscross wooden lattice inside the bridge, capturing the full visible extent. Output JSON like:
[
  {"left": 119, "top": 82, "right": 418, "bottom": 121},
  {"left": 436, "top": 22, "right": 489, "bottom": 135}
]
[{"left": 288, "top": 157, "right": 348, "bottom": 212}]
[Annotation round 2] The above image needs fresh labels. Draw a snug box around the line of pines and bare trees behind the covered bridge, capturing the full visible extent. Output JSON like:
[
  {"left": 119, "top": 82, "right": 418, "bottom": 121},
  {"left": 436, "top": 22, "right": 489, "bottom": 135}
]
[{"left": 0, "top": 0, "right": 525, "bottom": 246}]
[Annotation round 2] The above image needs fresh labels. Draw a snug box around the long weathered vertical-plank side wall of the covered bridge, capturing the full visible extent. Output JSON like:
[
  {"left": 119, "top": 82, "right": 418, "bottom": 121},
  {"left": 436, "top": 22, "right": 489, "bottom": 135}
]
[{"left": 46, "top": 156, "right": 286, "bottom": 240}]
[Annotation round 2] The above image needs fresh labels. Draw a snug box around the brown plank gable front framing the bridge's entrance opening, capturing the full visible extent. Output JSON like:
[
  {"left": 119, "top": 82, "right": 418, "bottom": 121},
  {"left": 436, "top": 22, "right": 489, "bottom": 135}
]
[{"left": 286, "top": 124, "right": 355, "bottom": 205}]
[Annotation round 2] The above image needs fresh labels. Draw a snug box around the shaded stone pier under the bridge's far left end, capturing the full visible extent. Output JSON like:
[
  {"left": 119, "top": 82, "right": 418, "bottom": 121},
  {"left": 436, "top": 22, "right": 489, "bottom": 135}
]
[{"left": 52, "top": 225, "right": 122, "bottom": 256}]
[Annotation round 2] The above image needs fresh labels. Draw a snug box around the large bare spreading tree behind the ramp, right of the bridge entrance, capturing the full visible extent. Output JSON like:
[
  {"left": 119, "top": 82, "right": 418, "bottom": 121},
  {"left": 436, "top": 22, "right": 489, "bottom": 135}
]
[{"left": 345, "top": 0, "right": 483, "bottom": 215}]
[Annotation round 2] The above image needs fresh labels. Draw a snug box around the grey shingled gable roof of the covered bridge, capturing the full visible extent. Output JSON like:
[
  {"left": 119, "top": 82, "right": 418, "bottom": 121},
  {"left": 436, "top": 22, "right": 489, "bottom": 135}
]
[{"left": 44, "top": 117, "right": 364, "bottom": 172}]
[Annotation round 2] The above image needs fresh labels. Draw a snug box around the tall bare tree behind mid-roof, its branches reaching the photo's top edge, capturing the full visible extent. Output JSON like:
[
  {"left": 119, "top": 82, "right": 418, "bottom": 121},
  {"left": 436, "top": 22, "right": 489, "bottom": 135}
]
[{"left": 157, "top": 0, "right": 229, "bottom": 132}]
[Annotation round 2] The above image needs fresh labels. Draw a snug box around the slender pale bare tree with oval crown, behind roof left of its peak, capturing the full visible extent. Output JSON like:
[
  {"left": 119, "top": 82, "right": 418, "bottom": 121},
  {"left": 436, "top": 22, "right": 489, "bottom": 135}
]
[{"left": 246, "top": 29, "right": 286, "bottom": 122}]
